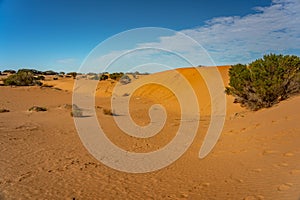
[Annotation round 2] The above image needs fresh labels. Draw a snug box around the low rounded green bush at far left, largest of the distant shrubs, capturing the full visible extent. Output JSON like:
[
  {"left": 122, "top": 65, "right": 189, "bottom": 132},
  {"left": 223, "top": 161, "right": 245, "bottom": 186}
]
[{"left": 3, "top": 71, "right": 42, "bottom": 86}]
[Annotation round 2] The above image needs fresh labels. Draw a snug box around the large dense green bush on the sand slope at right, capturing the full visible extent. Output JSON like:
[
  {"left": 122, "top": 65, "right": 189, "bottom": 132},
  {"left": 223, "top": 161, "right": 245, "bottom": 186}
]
[{"left": 225, "top": 54, "right": 300, "bottom": 110}]
